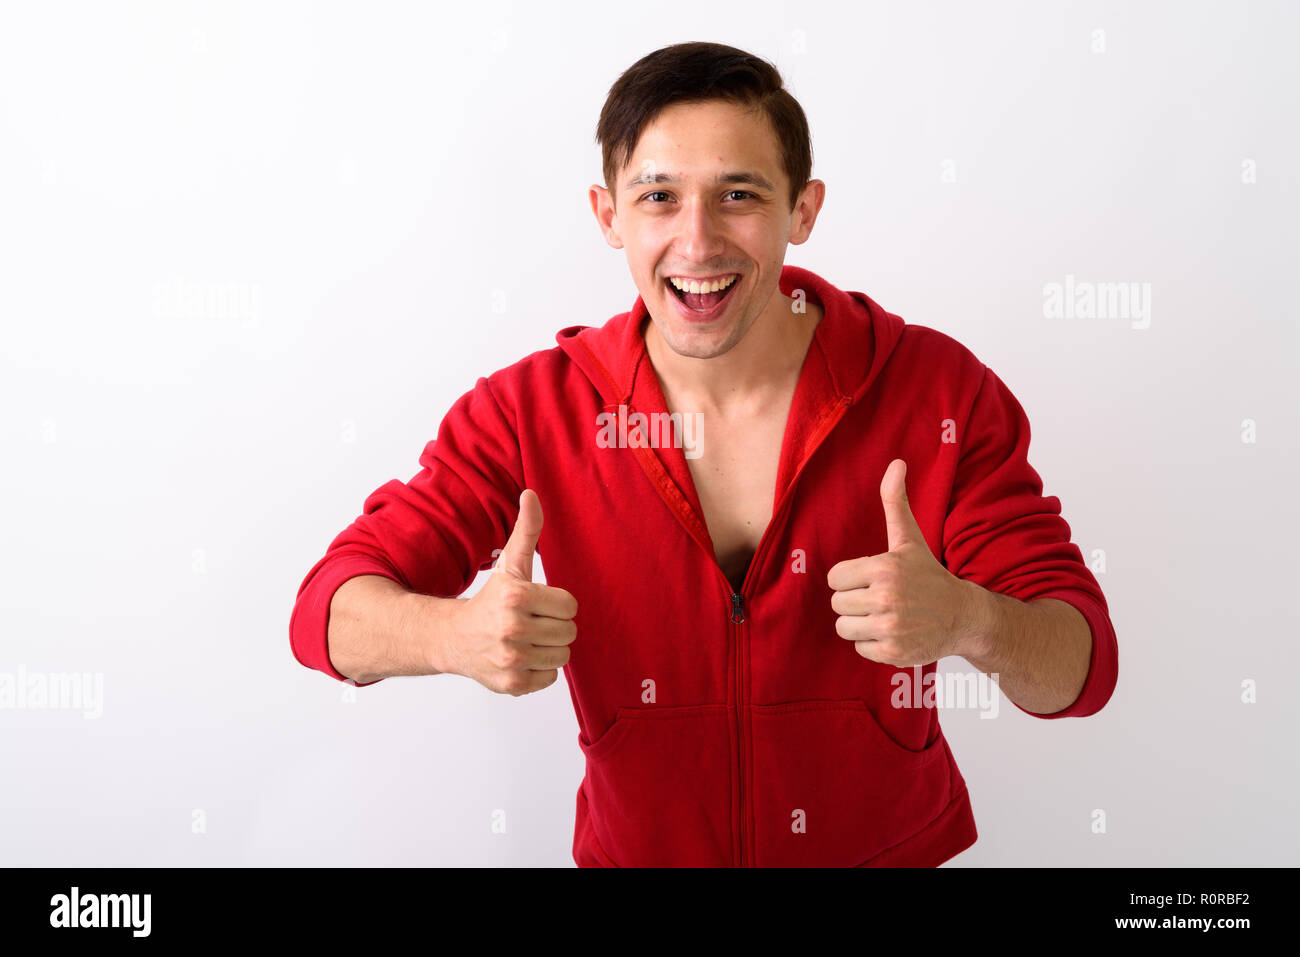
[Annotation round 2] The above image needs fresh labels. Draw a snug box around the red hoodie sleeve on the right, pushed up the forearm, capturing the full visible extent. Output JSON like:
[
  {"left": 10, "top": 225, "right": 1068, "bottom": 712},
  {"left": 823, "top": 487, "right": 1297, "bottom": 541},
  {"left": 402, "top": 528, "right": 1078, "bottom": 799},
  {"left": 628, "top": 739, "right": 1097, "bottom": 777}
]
[{"left": 943, "top": 365, "right": 1118, "bottom": 718}]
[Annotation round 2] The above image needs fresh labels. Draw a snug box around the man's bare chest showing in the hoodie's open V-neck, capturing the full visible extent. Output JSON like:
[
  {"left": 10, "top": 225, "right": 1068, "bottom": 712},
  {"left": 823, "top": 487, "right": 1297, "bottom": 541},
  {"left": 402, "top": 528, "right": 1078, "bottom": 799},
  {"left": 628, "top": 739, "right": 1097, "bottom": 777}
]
[{"left": 688, "top": 397, "right": 790, "bottom": 590}]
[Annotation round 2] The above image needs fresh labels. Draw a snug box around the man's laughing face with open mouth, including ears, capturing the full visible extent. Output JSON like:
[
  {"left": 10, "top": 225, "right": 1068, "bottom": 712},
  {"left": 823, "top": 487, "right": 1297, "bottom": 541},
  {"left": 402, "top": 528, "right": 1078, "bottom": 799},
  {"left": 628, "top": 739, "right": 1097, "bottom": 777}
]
[{"left": 590, "top": 100, "right": 826, "bottom": 359}]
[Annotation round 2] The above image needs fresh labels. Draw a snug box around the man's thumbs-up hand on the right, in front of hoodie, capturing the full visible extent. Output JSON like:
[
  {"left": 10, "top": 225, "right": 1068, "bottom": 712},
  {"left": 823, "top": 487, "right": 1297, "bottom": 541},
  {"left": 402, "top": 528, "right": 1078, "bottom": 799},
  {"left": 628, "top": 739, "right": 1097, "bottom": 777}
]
[{"left": 826, "top": 459, "right": 979, "bottom": 668}]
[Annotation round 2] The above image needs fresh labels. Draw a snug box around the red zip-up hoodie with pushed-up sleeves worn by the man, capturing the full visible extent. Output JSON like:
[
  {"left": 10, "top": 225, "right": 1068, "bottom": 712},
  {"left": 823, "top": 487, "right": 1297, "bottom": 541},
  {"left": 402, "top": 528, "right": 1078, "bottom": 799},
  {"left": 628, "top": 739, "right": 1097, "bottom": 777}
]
[{"left": 290, "top": 265, "right": 1117, "bottom": 866}]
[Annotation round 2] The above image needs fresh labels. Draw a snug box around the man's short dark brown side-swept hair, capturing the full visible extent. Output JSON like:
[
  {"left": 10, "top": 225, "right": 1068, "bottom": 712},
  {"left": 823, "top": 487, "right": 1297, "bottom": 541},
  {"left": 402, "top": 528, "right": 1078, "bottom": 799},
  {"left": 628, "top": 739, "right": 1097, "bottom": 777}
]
[{"left": 595, "top": 42, "right": 813, "bottom": 209}]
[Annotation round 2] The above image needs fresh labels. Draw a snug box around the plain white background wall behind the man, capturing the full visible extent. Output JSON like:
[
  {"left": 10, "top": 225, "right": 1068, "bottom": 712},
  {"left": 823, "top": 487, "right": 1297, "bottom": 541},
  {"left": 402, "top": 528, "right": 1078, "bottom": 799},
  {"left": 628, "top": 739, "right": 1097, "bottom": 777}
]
[{"left": 0, "top": 0, "right": 1300, "bottom": 866}]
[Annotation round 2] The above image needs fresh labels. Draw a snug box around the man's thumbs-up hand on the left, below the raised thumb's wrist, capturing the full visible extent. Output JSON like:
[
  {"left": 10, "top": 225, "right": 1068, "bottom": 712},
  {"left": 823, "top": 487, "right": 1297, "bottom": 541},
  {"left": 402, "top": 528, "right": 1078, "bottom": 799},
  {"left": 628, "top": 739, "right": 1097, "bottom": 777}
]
[{"left": 447, "top": 489, "right": 577, "bottom": 697}]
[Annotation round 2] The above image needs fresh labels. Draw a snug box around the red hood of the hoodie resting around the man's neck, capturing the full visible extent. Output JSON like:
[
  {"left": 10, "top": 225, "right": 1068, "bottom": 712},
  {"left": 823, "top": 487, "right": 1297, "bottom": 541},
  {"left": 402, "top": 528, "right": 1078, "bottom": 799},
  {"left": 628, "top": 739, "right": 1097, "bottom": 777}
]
[{"left": 555, "top": 265, "right": 905, "bottom": 406}]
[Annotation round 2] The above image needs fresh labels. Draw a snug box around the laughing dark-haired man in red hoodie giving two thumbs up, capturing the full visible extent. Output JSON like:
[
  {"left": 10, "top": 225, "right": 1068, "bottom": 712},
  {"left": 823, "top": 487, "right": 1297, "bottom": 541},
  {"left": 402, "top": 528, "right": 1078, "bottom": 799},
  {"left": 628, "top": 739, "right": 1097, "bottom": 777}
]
[{"left": 290, "top": 43, "right": 1117, "bottom": 866}]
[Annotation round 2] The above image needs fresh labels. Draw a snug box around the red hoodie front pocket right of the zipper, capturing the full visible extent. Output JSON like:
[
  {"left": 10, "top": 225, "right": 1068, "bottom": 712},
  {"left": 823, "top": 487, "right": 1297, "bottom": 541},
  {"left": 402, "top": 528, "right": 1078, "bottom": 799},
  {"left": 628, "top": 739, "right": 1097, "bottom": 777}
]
[{"left": 751, "top": 698, "right": 950, "bottom": 867}]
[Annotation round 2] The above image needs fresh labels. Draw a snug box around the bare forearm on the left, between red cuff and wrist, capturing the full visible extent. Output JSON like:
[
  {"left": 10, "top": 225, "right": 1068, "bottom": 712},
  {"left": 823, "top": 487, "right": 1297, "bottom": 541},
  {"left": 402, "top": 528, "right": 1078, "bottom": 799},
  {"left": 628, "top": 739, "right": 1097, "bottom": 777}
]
[{"left": 329, "top": 575, "right": 460, "bottom": 684}]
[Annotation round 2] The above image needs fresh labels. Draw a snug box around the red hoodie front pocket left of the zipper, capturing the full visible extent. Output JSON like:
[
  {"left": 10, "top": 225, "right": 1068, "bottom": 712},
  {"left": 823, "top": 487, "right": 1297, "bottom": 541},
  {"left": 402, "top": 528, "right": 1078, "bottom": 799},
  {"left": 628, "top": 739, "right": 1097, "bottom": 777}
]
[{"left": 579, "top": 705, "right": 732, "bottom": 867}]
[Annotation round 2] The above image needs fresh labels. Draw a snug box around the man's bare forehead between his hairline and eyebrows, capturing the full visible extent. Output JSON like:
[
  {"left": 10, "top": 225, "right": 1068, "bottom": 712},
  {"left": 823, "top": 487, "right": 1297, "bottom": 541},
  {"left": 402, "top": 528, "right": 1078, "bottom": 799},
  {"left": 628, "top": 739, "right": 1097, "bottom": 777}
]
[{"left": 625, "top": 100, "right": 781, "bottom": 176}]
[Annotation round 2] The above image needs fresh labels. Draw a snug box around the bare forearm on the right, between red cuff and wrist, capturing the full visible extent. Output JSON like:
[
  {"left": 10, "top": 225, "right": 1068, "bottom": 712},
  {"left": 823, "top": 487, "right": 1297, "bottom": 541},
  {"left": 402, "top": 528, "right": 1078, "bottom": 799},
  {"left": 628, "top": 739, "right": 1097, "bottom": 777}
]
[{"left": 958, "top": 583, "right": 1092, "bottom": 714}]
